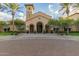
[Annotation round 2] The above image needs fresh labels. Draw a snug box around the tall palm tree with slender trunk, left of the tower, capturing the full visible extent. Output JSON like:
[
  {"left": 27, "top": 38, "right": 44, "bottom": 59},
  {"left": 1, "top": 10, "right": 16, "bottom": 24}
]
[{"left": 5, "top": 3, "right": 19, "bottom": 32}]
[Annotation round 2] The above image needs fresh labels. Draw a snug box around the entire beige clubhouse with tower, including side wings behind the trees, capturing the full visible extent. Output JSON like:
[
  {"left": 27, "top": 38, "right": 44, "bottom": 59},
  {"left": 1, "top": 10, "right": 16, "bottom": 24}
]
[{"left": 0, "top": 4, "right": 79, "bottom": 33}]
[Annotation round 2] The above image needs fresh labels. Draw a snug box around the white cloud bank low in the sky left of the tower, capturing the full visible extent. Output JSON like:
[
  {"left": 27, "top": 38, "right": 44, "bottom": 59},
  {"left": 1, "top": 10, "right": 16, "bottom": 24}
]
[{"left": 0, "top": 12, "right": 26, "bottom": 21}]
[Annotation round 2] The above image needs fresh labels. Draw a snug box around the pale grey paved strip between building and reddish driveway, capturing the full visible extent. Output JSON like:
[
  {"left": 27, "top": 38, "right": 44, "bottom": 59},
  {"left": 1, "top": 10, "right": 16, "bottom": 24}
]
[{"left": 0, "top": 33, "right": 79, "bottom": 41}]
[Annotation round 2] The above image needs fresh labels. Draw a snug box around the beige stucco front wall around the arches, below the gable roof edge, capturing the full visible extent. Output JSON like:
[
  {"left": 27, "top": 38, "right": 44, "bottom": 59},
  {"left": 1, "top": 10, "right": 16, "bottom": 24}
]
[{"left": 26, "top": 16, "right": 50, "bottom": 31}]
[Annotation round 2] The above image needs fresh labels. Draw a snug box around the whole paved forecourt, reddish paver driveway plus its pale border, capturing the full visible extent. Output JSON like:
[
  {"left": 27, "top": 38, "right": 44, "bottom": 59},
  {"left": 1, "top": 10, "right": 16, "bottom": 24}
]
[{"left": 0, "top": 34, "right": 79, "bottom": 56}]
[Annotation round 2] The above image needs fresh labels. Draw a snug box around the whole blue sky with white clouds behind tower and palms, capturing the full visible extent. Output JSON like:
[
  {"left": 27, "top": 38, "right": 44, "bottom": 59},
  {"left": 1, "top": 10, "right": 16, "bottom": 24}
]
[{"left": 0, "top": 3, "right": 77, "bottom": 20}]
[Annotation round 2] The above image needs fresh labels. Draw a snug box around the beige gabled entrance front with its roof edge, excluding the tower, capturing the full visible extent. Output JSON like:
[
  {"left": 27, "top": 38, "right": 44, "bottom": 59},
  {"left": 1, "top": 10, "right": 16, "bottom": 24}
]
[{"left": 26, "top": 12, "right": 51, "bottom": 32}]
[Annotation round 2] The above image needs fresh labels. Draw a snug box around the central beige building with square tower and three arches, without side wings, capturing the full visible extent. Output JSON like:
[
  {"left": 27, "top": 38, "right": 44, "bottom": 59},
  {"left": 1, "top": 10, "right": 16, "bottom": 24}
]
[{"left": 26, "top": 4, "right": 52, "bottom": 33}]
